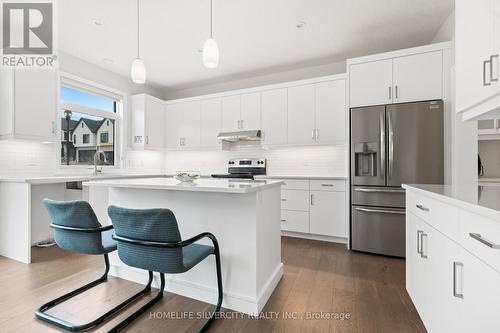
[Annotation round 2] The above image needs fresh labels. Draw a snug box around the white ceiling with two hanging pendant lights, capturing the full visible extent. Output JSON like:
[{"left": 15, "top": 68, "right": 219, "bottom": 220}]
[{"left": 58, "top": 0, "right": 453, "bottom": 89}]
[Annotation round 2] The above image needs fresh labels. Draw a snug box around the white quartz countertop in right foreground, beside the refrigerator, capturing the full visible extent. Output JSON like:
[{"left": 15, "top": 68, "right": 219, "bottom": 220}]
[{"left": 403, "top": 184, "right": 500, "bottom": 221}]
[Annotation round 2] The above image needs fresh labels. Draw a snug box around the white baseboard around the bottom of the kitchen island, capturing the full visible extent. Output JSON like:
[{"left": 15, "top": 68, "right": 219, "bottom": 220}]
[{"left": 109, "top": 263, "right": 283, "bottom": 315}]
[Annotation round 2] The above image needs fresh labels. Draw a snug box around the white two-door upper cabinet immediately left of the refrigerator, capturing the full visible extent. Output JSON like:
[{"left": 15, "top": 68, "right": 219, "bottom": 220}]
[{"left": 288, "top": 78, "right": 346, "bottom": 144}]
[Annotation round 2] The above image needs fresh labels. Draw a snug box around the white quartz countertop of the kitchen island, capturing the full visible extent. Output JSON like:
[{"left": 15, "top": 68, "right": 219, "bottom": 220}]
[{"left": 83, "top": 177, "right": 282, "bottom": 193}]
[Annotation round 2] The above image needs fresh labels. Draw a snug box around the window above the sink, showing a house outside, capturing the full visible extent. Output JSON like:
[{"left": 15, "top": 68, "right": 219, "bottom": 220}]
[{"left": 60, "top": 78, "right": 121, "bottom": 166}]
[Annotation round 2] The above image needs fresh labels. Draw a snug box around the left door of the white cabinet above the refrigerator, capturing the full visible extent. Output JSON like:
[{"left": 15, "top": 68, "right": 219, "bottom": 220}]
[{"left": 349, "top": 59, "right": 394, "bottom": 107}]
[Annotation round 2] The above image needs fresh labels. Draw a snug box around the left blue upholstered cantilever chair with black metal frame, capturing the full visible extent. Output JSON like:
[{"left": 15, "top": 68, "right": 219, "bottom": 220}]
[{"left": 35, "top": 199, "right": 153, "bottom": 332}]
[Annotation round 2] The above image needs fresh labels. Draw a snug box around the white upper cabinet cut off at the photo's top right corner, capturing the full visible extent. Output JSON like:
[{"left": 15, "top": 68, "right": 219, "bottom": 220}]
[{"left": 455, "top": 0, "right": 500, "bottom": 119}]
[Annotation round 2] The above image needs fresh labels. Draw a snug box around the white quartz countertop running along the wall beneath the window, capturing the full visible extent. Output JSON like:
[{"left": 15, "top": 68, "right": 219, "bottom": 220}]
[{"left": 0, "top": 172, "right": 164, "bottom": 185}]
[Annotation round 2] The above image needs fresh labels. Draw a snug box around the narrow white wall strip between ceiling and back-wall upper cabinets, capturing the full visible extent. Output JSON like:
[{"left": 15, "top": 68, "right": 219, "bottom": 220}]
[{"left": 164, "top": 61, "right": 346, "bottom": 100}]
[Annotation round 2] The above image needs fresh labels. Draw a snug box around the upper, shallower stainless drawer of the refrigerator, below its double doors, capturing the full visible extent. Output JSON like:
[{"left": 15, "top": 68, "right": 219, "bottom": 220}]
[{"left": 352, "top": 186, "right": 405, "bottom": 208}]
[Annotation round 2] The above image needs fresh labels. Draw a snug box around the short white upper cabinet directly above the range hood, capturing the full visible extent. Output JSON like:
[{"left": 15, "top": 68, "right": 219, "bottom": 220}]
[{"left": 222, "top": 92, "right": 260, "bottom": 132}]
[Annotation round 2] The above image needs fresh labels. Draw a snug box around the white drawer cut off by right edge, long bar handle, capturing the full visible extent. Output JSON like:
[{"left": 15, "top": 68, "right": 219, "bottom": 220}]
[{"left": 457, "top": 210, "right": 500, "bottom": 272}]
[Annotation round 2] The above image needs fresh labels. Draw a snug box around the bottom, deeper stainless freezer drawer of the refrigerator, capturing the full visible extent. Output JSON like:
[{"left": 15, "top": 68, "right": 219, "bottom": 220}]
[{"left": 351, "top": 206, "right": 406, "bottom": 257}]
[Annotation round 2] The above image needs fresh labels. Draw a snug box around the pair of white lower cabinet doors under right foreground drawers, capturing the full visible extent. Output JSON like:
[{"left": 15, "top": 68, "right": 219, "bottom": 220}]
[{"left": 406, "top": 196, "right": 500, "bottom": 332}]
